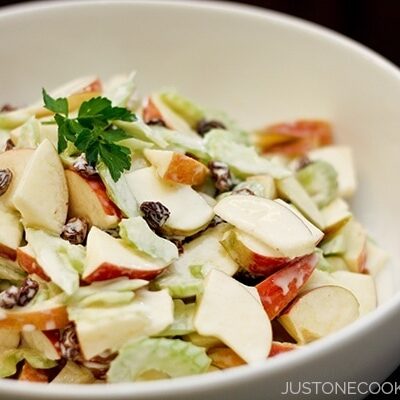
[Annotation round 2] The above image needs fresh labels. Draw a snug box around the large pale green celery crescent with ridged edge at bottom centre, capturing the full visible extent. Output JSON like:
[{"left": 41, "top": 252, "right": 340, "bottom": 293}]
[{"left": 107, "top": 338, "right": 211, "bottom": 383}]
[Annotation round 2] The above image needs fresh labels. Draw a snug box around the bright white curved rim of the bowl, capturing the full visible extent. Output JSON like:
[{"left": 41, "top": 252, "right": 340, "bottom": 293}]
[{"left": 0, "top": 0, "right": 400, "bottom": 399}]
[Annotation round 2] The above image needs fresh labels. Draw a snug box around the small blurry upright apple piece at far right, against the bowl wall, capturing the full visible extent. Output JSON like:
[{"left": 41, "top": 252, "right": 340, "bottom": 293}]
[{"left": 341, "top": 219, "right": 367, "bottom": 272}]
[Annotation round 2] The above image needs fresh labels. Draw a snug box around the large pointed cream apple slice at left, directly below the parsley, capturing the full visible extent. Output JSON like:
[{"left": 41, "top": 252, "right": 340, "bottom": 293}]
[{"left": 13, "top": 140, "right": 68, "bottom": 235}]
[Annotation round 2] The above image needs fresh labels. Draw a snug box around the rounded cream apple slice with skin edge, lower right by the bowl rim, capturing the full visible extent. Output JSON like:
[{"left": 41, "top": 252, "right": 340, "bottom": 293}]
[{"left": 279, "top": 285, "right": 359, "bottom": 344}]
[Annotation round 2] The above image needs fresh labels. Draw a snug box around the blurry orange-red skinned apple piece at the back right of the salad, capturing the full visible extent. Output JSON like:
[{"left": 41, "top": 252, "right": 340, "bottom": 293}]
[{"left": 256, "top": 120, "right": 332, "bottom": 156}]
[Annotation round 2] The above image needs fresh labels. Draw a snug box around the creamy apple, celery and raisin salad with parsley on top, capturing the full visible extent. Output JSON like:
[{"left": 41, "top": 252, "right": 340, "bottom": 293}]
[{"left": 0, "top": 74, "right": 386, "bottom": 383}]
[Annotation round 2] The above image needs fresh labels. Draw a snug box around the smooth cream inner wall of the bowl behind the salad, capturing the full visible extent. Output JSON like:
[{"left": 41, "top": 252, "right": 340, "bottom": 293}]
[{"left": 0, "top": 1, "right": 400, "bottom": 386}]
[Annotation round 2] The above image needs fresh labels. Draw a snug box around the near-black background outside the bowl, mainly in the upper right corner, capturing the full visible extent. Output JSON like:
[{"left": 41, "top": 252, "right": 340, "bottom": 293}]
[{"left": 0, "top": 0, "right": 400, "bottom": 397}]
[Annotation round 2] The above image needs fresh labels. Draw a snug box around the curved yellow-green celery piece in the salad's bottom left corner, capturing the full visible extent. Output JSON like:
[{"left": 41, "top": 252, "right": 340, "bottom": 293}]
[{"left": 0, "top": 348, "right": 57, "bottom": 378}]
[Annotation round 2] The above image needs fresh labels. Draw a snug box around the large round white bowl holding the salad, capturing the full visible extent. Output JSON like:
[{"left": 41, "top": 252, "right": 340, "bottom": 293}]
[{"left": 0, "top": 1, "right": 400, "bottom": 400}]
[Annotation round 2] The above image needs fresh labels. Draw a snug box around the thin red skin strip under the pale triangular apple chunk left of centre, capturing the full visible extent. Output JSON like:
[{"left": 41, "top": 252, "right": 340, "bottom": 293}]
[{"left": 84, "top": 262, "right": 164, "bottom": 283}]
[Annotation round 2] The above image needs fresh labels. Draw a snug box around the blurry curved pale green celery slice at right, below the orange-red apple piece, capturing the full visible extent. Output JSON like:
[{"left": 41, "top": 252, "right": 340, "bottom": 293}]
[{"left": 296, "top": 161, "right": 339, "bottom": 208}]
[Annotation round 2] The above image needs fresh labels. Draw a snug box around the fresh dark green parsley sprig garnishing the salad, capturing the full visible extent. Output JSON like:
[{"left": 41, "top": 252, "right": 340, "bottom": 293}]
[{"left": 42, "top": 89, "right": 136, "bottom": 182}]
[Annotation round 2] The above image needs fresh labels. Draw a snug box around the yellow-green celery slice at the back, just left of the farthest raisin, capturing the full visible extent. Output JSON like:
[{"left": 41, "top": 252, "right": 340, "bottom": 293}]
[{"left": 159, "top": 91, "right": 204, "bottom": 129}]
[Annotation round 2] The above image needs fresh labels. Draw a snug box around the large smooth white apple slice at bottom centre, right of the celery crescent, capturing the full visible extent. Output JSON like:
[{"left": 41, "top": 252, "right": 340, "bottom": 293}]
[{"left": 194, "top": 269, "right": 272, "bottom": 363}]
